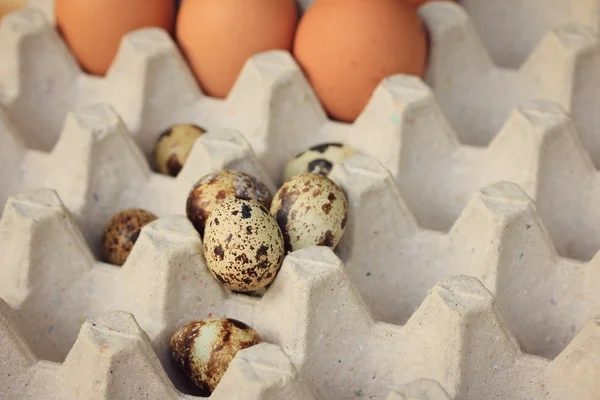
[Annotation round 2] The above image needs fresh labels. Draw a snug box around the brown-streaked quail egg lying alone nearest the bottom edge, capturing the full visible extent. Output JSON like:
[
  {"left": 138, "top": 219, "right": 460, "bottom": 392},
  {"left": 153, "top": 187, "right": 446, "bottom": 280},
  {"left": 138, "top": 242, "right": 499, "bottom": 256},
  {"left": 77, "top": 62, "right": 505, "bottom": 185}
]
[{"left": 171, "top": 318, "right": 262, "bottom": 395}]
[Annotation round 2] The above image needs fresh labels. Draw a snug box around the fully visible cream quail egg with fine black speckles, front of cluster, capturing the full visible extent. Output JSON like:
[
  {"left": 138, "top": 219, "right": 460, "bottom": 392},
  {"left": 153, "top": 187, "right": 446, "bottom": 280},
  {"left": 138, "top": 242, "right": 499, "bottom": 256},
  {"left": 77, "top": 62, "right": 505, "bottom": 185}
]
[{"left": 204, "top": 197, "right": 284, "bottom": 292}]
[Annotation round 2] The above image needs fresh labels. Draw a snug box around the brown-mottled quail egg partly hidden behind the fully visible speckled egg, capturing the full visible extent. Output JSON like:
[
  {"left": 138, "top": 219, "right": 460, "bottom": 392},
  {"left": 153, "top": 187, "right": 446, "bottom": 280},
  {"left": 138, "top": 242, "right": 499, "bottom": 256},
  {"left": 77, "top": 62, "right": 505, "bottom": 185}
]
[{"left": 186, "top": 170, "right": 272, "bottom": 236}]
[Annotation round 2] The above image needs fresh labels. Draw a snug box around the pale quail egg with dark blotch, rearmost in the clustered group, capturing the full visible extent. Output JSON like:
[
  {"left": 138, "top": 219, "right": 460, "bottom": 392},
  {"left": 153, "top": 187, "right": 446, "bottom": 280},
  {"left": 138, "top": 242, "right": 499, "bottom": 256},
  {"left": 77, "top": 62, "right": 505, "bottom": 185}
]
[{"left": 283, "top": 143, "right": 357, "bottom": 181}]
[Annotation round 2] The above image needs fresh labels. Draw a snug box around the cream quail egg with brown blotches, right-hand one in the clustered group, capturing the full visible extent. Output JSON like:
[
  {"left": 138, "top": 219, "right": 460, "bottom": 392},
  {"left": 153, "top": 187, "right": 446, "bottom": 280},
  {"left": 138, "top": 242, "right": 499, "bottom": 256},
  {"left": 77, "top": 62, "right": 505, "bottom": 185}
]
[{"left": 271, "top": 174, "right": 348, "bottom": 252}]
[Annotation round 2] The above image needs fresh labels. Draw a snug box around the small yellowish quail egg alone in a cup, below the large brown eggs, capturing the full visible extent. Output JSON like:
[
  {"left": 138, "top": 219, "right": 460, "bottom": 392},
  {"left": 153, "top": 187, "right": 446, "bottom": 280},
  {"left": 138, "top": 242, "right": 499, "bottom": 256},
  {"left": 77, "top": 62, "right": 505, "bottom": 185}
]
[{"left": 153, "top": 124, "right": 206, "bottom": 176}]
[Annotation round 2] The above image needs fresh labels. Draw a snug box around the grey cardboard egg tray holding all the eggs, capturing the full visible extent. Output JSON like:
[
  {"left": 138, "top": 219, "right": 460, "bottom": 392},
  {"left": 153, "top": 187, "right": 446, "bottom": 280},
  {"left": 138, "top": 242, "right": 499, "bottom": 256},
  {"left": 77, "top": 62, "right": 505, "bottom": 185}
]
[{"left": 0, "top": 0, "right": 600, "bottom": 400}]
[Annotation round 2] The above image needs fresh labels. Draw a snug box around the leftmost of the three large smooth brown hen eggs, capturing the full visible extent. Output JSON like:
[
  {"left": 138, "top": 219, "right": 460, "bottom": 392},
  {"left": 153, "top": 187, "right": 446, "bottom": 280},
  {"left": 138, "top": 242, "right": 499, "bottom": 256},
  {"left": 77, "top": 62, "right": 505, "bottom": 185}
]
[{"left": 54, "top": 0, "right": 175, "bottom": 75}]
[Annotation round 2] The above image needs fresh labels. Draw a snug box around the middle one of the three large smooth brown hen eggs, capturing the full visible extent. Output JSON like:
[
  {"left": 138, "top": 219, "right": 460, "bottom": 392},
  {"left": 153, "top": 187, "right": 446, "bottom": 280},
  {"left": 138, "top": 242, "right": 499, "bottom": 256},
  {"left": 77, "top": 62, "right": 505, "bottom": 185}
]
[{"left": 176, "top": 0, "right": 298, "bottom": 98}]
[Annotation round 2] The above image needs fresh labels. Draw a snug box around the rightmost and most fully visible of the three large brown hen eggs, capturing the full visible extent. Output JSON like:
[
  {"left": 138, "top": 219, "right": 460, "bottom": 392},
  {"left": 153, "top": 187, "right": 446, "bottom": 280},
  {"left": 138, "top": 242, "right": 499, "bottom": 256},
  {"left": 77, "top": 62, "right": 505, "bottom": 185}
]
[{"left": 294, "top": 0, "right": 427, "bottom": 122}]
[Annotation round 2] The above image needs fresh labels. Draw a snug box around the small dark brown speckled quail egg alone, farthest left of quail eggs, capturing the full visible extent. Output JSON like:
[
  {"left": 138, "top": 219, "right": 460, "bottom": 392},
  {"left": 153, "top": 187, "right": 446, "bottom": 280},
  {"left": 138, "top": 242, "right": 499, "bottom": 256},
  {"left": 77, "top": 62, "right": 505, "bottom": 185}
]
[{"left": 102, "top": 208, "right": 157, "bottom": 265}]
